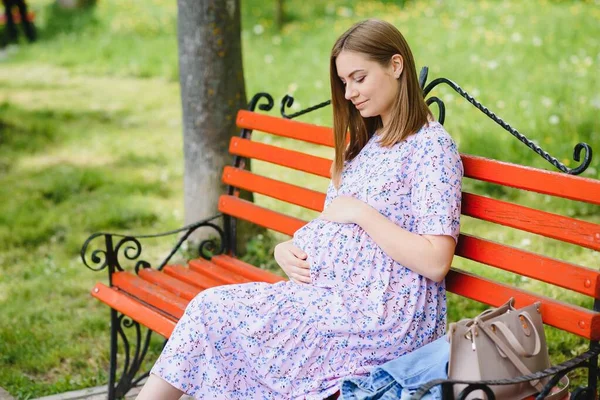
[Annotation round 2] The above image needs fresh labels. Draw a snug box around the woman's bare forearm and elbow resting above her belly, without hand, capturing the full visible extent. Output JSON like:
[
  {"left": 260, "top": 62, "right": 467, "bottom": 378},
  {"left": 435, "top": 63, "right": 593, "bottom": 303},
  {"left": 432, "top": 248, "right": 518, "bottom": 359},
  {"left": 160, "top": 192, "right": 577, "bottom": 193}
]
[{"left": 356, "top": 207, "right": 454, "bottom": 282}]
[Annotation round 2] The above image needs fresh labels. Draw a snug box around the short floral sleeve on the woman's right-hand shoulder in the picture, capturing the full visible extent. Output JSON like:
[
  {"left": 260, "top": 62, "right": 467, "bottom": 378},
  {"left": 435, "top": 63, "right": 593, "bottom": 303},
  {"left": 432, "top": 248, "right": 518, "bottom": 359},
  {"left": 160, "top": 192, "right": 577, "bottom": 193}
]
[{"left": 411, "top": 126, "right": 463, "bottom": 241}]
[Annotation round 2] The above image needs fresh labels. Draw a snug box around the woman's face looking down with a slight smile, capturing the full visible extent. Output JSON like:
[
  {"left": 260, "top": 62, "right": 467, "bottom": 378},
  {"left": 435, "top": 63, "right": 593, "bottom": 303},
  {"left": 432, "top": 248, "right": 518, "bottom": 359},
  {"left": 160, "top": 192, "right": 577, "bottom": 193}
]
[{"left": 335, "top": 50, "right": 402, "bottom": 126}]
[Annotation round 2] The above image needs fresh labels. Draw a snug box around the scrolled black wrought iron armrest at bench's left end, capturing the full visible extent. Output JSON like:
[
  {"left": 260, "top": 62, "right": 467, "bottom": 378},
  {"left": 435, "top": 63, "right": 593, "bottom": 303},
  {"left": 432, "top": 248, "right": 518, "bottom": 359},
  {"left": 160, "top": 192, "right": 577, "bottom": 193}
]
[{"left": 81, "top": 214, "right": 226, "bottom": 278}]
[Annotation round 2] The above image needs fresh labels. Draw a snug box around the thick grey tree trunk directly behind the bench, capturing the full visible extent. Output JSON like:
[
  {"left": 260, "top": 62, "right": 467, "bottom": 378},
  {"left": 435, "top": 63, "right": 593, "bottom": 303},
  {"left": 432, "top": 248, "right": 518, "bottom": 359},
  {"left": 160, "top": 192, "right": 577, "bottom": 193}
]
[{"left": 177, "top": 0, "right": 258, "bottom": 255}]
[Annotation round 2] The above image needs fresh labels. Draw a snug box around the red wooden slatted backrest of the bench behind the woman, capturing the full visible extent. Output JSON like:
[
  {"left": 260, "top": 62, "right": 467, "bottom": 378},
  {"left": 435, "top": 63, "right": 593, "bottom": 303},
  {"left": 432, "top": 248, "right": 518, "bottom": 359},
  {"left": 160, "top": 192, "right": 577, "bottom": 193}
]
[{"left": 219, "top": 111, "right": 600, "bottom": 340}]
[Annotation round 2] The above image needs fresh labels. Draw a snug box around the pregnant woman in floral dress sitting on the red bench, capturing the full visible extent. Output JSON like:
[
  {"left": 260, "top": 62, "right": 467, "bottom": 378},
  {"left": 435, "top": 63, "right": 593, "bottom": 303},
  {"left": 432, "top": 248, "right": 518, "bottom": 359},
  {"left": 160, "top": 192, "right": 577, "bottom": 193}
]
[{"left": 138, "top": 20, "right": 463, "bottom": 399}]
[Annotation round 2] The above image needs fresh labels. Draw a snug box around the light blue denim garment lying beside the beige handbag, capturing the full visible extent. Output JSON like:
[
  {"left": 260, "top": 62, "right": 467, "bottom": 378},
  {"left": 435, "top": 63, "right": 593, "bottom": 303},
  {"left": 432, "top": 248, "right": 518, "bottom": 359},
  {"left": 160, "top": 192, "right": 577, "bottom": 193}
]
[{"left": 340, "top": 336, "right": 450, "bottom": 400}]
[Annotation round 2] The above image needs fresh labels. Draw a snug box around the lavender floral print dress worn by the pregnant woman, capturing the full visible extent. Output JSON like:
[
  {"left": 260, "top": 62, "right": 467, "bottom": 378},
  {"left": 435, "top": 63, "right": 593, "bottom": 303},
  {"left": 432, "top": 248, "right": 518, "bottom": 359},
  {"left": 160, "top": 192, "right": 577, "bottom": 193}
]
[{"left": 152, "top": 122, "right": 463, "bottom": 399}]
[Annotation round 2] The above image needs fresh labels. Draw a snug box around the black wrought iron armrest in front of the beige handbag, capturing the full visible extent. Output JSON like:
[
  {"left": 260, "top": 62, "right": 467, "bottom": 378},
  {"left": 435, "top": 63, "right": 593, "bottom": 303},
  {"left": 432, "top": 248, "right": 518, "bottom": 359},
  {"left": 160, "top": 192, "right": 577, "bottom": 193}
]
[{"left": 410, "top": 344, "right": 600, "bottom": 400}]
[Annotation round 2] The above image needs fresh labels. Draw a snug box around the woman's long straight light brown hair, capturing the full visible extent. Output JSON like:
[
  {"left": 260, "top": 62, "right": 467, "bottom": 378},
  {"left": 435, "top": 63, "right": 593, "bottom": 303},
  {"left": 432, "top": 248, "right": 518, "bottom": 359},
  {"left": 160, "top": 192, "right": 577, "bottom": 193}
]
[{"left": 330, "top": 19, "right": 432, "bottom": 188}]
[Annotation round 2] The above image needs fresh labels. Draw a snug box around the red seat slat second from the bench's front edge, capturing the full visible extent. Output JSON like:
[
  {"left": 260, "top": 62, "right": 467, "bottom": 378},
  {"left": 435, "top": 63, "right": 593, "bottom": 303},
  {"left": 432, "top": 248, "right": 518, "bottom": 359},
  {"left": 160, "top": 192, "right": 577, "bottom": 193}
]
[{"left": 113, "top": 272, "right": 188, "bottom": 319}]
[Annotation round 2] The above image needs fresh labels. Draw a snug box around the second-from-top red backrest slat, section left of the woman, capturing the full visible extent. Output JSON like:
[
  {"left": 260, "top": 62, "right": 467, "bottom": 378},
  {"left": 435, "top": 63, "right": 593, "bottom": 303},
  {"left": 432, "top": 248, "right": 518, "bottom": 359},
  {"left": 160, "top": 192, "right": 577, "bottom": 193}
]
[{"left": 229, "top": 137, "right": 331, "bottom": 178}]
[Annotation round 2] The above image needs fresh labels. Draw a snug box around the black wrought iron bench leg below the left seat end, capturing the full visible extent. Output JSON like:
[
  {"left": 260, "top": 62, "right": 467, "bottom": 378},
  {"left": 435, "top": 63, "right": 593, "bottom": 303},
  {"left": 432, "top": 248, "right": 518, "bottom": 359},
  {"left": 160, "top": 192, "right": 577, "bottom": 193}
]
[{"left": 108, "top": 309, "right": 152, "bottom": 400}]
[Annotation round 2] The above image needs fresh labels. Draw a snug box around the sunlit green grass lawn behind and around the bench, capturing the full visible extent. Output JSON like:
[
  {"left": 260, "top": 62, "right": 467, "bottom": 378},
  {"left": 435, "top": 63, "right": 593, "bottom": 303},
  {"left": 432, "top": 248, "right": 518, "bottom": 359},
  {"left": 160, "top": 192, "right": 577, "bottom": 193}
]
[{"left": 0, "top": 0, "right": 600, "bottom": 399}]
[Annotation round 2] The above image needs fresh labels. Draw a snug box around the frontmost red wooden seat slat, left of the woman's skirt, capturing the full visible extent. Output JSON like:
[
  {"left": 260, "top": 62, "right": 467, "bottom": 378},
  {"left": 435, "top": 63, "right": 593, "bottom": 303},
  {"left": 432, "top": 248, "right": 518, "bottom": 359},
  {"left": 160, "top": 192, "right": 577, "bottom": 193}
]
[{"left": 92, "top": 283, "right": 176, "bottom": 338}]
